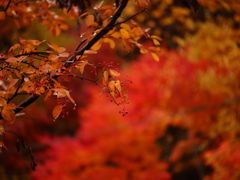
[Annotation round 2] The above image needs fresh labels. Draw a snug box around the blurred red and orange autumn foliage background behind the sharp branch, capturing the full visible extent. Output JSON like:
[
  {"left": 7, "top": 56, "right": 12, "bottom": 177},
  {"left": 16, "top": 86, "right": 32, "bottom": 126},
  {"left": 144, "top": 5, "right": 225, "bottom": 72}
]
[{"left": 0, "top": 0, "right": 240, "bottom": 180}]
